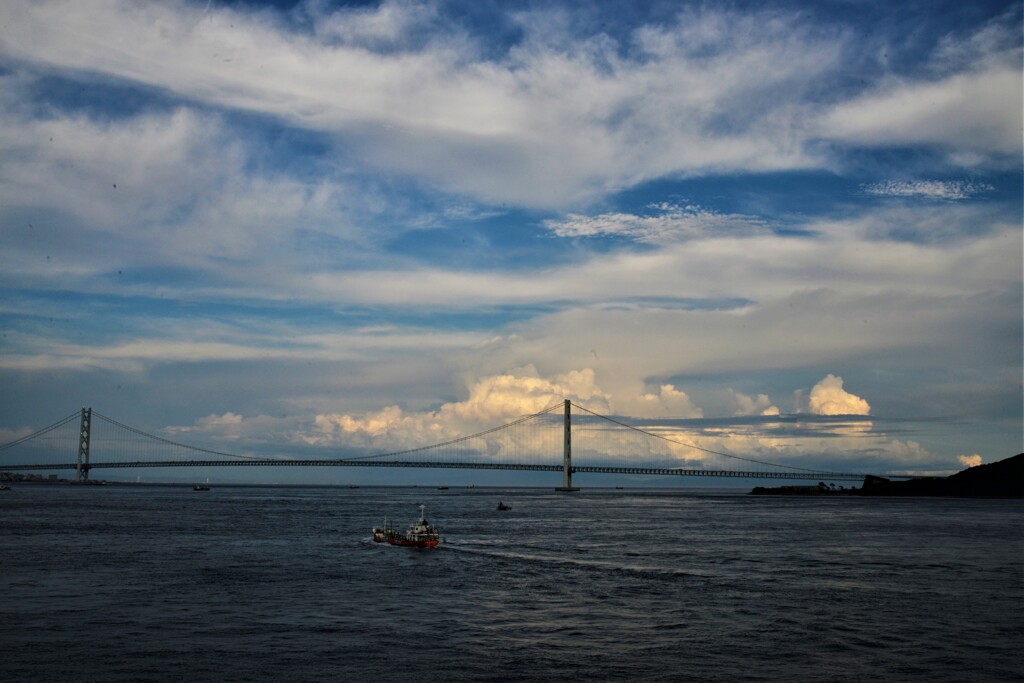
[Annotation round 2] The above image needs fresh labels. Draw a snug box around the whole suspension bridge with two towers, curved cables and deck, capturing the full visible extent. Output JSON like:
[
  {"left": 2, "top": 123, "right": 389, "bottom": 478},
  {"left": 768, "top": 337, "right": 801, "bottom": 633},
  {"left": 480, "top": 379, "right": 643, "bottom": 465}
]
[{"left": 0, "top": 399, "right": 888, "bottom": 490}]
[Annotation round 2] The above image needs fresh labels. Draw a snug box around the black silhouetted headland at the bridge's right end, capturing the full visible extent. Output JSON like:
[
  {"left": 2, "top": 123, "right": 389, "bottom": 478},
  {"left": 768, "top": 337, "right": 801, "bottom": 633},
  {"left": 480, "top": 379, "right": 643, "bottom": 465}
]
[{"left": 751, "top": 454, "right": 1024, "bottom": 498}]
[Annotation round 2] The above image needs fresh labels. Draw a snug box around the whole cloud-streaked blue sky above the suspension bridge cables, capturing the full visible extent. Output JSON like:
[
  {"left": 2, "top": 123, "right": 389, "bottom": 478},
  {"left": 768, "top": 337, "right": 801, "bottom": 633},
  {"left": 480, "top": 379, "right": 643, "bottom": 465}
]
[{"left": 0, "top": 0, "right": 1024, "bottom": 478}]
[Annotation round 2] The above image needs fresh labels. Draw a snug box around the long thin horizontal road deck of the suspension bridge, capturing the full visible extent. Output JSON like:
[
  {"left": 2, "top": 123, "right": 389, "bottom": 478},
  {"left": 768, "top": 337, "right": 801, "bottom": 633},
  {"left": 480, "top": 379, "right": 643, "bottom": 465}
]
[{"left": 0, "top": 459, "right": 864, "bottom": 481}]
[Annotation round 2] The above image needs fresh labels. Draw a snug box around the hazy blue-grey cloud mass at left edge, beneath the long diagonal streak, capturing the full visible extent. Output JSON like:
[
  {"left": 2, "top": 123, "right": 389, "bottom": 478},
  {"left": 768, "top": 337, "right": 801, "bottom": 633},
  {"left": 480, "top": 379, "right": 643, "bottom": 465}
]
[{"left": 0, "top": 103, "right": 372, "bottom": 286}]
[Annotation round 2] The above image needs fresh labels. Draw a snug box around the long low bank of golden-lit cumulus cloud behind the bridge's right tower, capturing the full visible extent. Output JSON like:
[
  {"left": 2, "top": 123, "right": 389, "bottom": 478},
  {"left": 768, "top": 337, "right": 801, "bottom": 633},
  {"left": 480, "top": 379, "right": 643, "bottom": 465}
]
[{"left": 148, "top": 367, "right": 935, "bottom": 471}]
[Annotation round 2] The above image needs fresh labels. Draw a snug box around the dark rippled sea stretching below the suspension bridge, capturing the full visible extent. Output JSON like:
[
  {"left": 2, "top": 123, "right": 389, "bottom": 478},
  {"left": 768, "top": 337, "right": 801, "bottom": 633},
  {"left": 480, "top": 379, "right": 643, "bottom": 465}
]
[{"left": 0, "top": 485, "right": 1024, "bottom": 682}]
